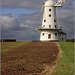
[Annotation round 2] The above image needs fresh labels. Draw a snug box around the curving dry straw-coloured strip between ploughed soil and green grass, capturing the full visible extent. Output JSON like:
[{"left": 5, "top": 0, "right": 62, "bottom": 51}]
[{"left": 43, "top": 42, "right": 62, "bottom": 75}]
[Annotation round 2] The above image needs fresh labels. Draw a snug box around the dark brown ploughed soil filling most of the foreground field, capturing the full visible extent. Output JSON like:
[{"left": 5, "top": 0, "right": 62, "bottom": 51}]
[{"left": 1, "top": 42, "right": 59, "bottom": 75}]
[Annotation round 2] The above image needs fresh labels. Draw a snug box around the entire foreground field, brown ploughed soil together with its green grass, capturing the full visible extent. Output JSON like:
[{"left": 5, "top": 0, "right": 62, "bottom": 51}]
[{"left": 1, "top": 42, "right": 74, "bottom": 75}]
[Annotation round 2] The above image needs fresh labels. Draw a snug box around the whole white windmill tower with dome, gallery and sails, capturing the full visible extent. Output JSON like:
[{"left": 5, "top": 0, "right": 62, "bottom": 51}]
[{"left": 36, "top": 0, "right": 65, "bottom": 41}]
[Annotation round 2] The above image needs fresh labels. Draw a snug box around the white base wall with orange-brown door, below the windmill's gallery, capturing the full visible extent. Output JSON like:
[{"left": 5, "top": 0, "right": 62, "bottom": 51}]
[{"left": 40, "top": 30, "right": 59, "bottom": 41}]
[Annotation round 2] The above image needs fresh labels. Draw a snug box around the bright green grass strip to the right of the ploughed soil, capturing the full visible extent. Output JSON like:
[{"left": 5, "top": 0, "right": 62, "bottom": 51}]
[{"left": 54, "top": 42, "right": 74, "bottom": 75}]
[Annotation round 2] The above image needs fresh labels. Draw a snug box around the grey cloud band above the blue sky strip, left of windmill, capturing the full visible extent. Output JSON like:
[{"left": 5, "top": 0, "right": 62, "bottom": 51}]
[{"left": 1, "top": 0, "right": 42, "bottom": 9}]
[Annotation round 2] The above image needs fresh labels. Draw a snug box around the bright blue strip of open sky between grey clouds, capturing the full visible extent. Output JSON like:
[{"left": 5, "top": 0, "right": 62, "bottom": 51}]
[{"left": 1, "top": 8, "right": 39, "bottom": 17}]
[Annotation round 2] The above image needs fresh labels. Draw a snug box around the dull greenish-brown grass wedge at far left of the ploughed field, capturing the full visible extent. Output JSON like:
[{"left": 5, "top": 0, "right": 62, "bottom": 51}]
[{"left": 1, "top": 42, "right": 28, "bottom": 52}]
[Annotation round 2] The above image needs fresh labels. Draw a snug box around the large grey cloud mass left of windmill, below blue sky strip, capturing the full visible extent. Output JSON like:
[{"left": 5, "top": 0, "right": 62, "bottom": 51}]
[{"left": 1, "top": 13, "right": 41, "bottom": 41}]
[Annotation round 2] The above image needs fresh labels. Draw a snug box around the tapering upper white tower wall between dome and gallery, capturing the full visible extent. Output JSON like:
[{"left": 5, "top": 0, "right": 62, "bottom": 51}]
[{"left": 42, "top": 6, "right": 58, "bottom": 29}]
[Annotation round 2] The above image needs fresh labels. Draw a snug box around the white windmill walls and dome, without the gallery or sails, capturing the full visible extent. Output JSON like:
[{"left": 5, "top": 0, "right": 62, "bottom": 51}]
[{"left": 40, "top": 0, "right": 59, "bottom": 41}]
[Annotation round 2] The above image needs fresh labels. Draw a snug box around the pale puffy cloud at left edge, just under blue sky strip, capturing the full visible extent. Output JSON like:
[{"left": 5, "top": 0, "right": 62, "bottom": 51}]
[{"left": 1, "top": 16, "right": 16, "bottom": 29}]
